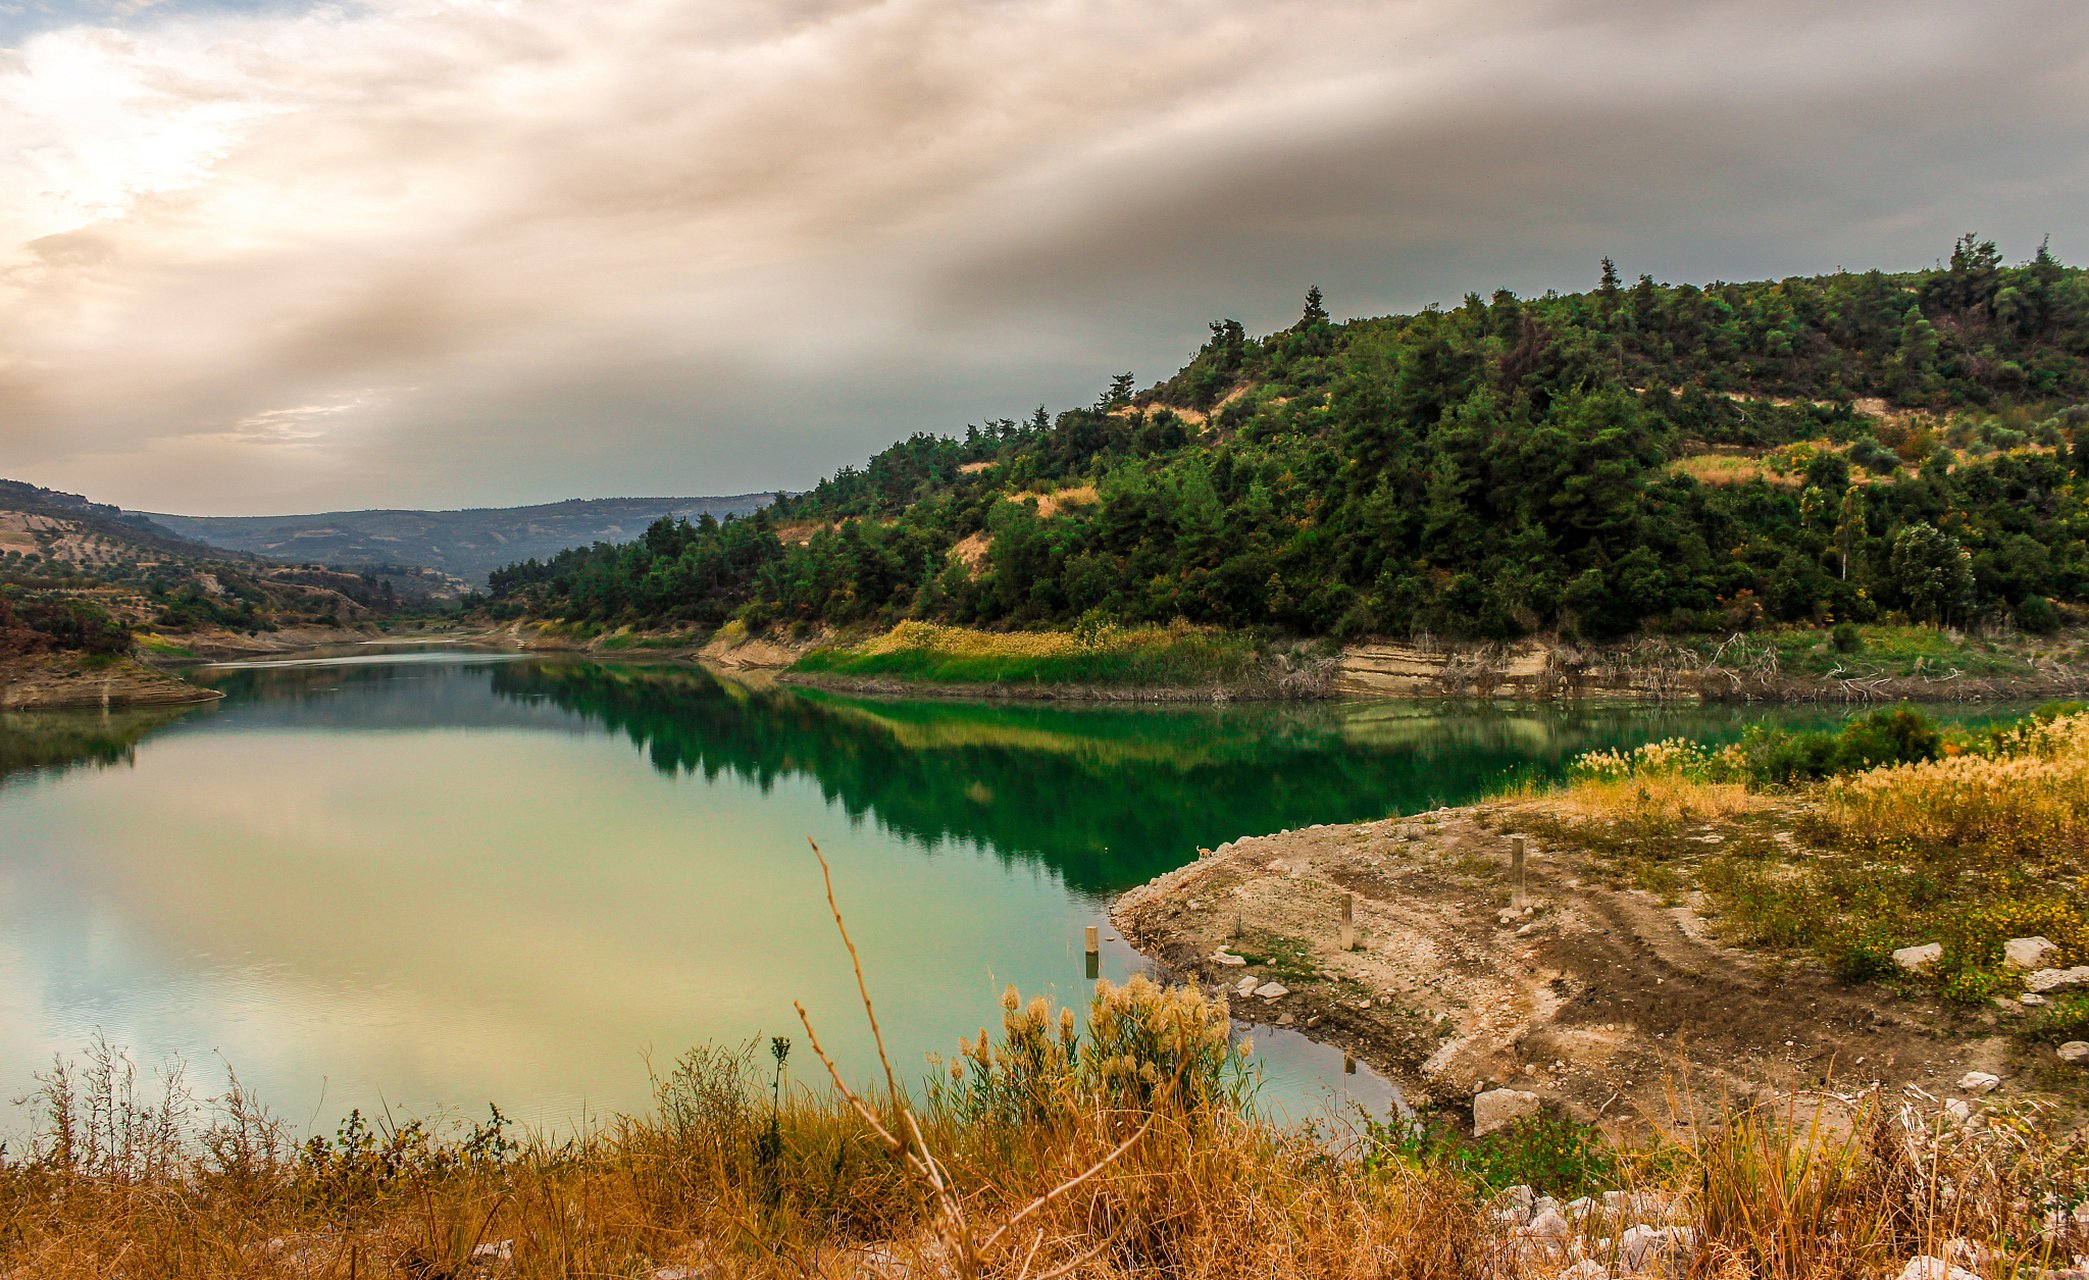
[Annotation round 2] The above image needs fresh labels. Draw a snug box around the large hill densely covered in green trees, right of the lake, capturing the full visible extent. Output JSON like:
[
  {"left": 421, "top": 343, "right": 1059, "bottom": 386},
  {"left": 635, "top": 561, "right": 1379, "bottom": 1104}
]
[{"left": 491, "top": 236, "right": 2089, "bottom": 637}]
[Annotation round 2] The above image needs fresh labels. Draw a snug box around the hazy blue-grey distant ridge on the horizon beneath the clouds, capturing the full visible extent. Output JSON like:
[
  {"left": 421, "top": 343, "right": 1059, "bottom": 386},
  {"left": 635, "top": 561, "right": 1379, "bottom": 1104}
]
[{"left": 150, "top": 493, "right": 775, "bottom": 585}]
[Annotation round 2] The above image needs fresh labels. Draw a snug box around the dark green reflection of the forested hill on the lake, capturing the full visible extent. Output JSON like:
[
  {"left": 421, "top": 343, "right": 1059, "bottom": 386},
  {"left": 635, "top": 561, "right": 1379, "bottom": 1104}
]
[{"left": 491, "top": 662, "right": 1763, "bottom": 892}]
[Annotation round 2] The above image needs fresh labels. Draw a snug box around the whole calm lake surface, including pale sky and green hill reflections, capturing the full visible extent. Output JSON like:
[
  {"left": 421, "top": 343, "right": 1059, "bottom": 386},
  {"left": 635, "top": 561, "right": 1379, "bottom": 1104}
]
[{"left": 0, "top": 647, "right": 2022, "bottom": 1132}]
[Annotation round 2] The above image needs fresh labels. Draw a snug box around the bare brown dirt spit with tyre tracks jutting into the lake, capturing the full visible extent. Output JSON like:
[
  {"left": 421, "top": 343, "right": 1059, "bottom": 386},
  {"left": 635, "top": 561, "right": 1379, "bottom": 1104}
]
[{"left": 1111, "top": 802, "right": 2058, "bottom": 1125}]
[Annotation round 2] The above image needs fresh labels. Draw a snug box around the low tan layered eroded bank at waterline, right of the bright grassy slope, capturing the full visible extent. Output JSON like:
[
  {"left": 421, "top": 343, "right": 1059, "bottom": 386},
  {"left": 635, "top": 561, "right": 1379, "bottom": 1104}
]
[{"left": 1331, "top": 641, "right": 1717, "bottom": 700}]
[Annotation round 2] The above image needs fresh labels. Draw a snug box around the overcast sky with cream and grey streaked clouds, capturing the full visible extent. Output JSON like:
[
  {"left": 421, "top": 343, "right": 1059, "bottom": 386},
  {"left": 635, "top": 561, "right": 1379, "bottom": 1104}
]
[{"left": 0, "top": 0, "right": 2089, "bottom": 516}]
